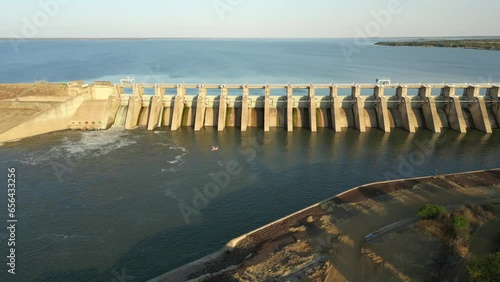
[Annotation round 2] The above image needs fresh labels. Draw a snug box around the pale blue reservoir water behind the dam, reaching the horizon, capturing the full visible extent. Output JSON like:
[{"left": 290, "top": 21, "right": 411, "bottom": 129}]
[{"left": 0, "top": 39, "right": 500, "bottom": 84}]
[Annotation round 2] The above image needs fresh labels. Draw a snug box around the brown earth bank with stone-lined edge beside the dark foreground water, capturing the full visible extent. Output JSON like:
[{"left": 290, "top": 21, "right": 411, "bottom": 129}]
[{"left": 151, "top": 169, "right": 500, "bottom": 281}]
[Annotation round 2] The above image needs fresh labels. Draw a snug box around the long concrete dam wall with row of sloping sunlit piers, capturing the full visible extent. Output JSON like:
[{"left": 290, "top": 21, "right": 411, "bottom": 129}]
[{"left": 0, "top": 81, "right": 500, "bottom": 142}]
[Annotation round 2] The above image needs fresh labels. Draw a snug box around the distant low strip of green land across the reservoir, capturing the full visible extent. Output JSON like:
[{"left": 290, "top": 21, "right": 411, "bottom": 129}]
[{"left": 375, "top": 39, "right": 500, "bottom": 51}]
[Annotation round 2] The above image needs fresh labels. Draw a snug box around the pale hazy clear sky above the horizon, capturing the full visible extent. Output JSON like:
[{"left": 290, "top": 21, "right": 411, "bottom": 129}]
[{"left": 0, "top": 0, "right": 500, "bottom": 37}]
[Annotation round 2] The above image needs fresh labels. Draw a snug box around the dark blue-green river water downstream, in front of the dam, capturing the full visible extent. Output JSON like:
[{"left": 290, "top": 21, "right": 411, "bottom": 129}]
[{"left": 0, "top": 128, "right": 500, "bottom": 281}]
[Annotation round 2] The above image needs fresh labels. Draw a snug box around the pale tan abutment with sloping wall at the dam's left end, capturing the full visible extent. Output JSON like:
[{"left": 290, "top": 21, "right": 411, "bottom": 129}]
[{"left": 0, "top": 82, "right": 119, "bottom": 143}]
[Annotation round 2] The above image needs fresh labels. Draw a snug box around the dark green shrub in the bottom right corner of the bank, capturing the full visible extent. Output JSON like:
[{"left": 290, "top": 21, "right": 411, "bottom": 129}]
[{"left": 467, "top": 252, "right": 500, "bottom": 282}]
